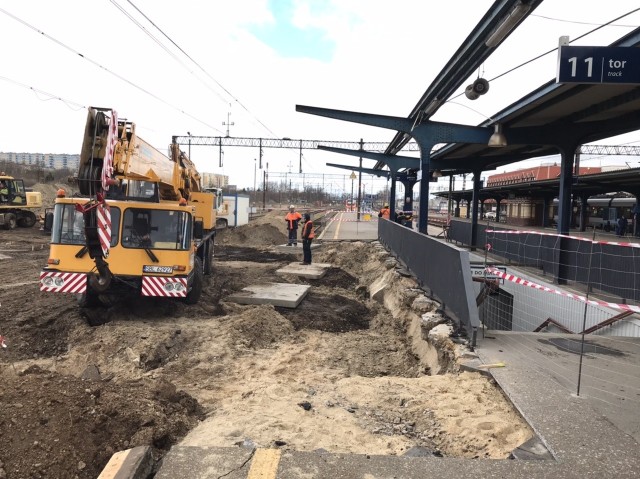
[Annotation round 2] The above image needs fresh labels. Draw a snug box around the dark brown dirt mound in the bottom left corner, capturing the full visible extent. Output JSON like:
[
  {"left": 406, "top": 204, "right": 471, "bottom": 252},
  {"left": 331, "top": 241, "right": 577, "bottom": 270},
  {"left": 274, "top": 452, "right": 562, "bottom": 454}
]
[{"left": 0, "top": 366, "right": 203, "bottom": 478}]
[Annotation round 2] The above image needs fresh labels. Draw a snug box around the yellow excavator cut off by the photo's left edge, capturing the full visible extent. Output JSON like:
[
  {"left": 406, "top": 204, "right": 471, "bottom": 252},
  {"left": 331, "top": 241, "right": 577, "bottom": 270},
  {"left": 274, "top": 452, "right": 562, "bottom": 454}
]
[{"left": 0, "top": 172, "right": 42, "bottom": 230}]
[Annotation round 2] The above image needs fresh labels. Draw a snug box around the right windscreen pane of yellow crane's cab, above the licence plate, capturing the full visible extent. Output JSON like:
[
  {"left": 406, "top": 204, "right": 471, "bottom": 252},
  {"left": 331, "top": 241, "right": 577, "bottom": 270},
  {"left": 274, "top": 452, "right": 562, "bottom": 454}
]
[{"left": 122, "top": 208, "right": 191, "bottom": 250}]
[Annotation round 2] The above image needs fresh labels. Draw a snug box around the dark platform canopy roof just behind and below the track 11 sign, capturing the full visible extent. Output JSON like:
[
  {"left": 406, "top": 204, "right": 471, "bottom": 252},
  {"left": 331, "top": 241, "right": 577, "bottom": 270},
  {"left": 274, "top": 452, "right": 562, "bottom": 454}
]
[{"left": 424, "top": 28, "right": 640, "bottom": 175}]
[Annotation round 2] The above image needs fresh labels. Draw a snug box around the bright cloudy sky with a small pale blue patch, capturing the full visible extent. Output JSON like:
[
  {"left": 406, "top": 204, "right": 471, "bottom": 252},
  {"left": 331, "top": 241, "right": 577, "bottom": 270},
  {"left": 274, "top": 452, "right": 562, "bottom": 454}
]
[{"left": 0, "top": 0, "right": 640, "bottom": 197}]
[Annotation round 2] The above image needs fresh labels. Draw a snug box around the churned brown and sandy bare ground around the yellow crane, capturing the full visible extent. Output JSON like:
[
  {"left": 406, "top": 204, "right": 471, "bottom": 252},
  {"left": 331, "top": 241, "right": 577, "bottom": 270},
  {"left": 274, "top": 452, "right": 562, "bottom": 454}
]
[{"left": 0, "top": 213, "right": 531, "bottom": 478}]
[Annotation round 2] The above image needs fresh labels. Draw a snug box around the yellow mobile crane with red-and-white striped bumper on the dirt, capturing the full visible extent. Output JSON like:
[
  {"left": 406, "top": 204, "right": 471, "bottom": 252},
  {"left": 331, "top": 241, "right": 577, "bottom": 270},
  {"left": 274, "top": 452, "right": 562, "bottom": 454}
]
[{"left": 40, "top": 108, "right": 216, "bottom": 307}]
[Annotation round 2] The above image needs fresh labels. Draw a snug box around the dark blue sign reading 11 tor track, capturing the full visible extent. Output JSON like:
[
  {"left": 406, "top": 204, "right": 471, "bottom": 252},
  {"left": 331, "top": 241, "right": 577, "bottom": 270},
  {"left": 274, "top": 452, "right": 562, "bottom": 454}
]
[{"left": 556, "top": 45, "right": 640, "bottom": 84}]
